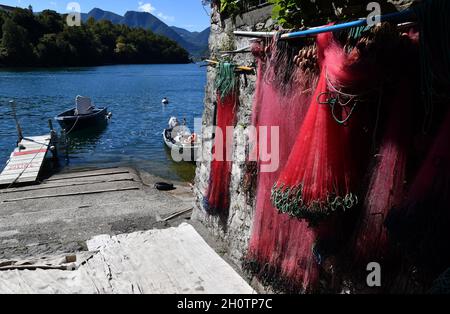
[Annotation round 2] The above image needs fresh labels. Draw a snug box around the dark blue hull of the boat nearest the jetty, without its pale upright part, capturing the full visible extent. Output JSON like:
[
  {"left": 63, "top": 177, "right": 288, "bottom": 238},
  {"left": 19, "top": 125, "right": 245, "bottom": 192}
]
[{"left": 56, "top": 108, "right": 110, "bottom": 133}]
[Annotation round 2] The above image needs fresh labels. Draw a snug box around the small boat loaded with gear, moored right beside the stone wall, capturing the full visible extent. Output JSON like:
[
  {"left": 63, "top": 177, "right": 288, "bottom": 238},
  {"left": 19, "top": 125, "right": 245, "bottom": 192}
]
[{"left": 162, "top": 117, "right": 201, "bottom": 162}]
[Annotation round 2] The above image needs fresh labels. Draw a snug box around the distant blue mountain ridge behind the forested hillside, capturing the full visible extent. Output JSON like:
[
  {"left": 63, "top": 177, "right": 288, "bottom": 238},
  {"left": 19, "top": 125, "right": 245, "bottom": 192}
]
[{"left": 81, "top": 8, "right": 210, "bottom": 56}]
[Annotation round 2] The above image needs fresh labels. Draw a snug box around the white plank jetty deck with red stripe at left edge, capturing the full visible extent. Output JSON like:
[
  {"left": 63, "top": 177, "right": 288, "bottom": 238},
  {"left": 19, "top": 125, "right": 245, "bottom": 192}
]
[{"left": 0, "top": 135, "right": 51, "bottom": 185}]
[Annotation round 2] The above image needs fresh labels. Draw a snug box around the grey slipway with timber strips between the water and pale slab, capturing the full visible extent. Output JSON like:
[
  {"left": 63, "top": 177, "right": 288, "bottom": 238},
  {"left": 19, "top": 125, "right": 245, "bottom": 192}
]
[{"left": 0, "top": 168, "right": 193, "bottom": 260}]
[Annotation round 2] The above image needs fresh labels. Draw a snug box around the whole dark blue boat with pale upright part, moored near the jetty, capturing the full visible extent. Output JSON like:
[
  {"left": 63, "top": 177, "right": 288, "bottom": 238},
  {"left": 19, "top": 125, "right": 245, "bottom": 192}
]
[{"left": 55, "top": 96, "right": 111, "bottom": 133}]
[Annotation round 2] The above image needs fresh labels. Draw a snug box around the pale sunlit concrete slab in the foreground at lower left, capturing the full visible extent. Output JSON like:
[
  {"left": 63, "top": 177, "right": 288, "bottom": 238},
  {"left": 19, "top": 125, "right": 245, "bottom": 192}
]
[{"left": 0, "top": 224, "right": 254, "bottom": 294}]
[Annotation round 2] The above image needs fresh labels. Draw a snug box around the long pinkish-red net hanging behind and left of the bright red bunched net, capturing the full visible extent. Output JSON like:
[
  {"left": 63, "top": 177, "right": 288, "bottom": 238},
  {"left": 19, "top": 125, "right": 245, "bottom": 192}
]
[{"left": 244, "top": 38, "right": 319, "bottom": 292}]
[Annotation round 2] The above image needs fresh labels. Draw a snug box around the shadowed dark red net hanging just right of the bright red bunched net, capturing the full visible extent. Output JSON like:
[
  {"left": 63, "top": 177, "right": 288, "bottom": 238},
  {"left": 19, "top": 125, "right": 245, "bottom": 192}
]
[{"left": 344, "top": 24, "right": 422, "bottom": 291}]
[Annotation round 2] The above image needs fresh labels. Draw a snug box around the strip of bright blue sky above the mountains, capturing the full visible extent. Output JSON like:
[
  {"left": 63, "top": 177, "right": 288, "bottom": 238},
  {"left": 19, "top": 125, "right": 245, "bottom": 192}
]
[{"left": 0, "top": 0, "right": 209, "bottom": 31}]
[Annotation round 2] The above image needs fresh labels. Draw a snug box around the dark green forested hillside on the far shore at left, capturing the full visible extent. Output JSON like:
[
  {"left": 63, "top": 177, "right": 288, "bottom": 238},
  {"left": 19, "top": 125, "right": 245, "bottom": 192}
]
[{"left": 0, "top": 8, "right": 189, "bottom": 66}]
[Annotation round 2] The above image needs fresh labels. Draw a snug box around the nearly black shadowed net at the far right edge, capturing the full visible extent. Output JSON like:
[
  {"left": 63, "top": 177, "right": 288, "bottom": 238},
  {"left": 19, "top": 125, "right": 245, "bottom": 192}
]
[{"left": 386, "top": 112, "right": 450, "bottom": 276}]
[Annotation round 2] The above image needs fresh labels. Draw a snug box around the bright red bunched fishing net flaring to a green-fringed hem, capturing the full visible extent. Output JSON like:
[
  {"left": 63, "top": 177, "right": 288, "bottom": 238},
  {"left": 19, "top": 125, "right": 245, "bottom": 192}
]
[{"left": 272, "top": 33, "right": 366, "bottom": 223}]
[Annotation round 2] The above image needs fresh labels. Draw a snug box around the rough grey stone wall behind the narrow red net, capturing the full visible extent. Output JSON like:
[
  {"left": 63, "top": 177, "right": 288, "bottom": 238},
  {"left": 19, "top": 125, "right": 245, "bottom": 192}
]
[{"left": 192, "top": 6, "right": 274, "bottom": 266}]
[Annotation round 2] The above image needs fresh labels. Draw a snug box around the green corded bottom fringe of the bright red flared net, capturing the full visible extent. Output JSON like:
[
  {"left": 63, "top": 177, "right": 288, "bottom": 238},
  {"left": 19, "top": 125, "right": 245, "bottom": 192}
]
[{"left": 271, "top": 184, "right": 358, "bottom": 222}]
